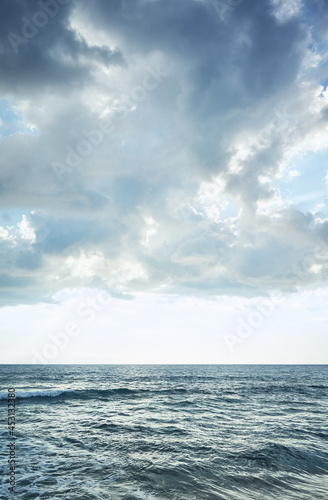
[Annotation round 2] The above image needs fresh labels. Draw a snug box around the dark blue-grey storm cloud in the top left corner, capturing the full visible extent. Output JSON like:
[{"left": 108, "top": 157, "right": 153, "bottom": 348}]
[{"left": 0, "top": 0, "right": 123, "bottom": 96}]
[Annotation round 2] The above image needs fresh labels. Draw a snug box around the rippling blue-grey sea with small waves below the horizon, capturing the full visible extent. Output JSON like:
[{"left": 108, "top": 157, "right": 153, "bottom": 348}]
[{"left": 0, "top": 365, "right": 328, "bottom": 500}]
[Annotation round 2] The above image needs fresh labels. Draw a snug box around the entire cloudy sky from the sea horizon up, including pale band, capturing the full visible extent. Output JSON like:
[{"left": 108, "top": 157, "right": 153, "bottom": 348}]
[{"left": 0, "top": 0, "right": 328, "bottom": 363}]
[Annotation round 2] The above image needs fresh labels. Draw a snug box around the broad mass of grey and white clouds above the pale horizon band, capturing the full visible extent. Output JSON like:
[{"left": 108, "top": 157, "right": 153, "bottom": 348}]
[{"left": 0, "top": 0, "right": 328, "bottom": 304}]
